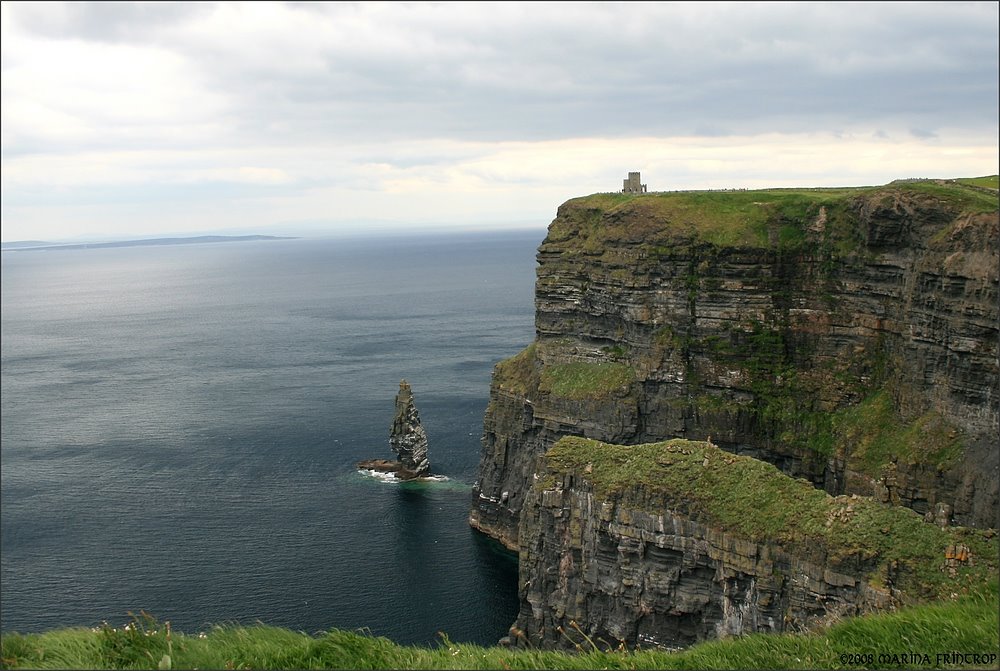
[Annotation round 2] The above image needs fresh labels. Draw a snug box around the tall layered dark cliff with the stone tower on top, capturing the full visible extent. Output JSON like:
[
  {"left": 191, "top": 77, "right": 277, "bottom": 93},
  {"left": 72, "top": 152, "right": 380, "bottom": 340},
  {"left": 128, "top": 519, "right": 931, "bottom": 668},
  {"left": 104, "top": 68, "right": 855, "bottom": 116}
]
[{"left": 470, "top": 182, "right": 1000, "bottom": 549}]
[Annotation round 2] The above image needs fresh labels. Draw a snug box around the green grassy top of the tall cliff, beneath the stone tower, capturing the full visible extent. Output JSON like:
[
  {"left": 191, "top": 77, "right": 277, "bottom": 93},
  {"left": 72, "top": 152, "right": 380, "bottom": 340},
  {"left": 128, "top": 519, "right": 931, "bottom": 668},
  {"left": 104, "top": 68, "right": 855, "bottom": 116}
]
[{"left": 543, "top": 176, "right": 998, "bottom": 252}]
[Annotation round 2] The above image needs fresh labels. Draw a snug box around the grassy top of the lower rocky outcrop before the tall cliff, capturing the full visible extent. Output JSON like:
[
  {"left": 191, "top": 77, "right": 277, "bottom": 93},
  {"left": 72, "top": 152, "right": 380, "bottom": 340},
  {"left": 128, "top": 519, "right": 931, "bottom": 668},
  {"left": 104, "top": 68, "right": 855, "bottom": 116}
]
[{"left": 539, "top": 437, "right": 998, "bottom": 598}]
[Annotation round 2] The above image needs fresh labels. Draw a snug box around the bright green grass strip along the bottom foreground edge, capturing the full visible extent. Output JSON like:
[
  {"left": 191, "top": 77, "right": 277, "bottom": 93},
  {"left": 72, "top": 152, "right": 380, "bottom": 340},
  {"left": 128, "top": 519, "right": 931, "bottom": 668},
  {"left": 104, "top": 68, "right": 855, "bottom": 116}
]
[{"left": 0, "top": 579, "right": 1000, "bottom": 669}]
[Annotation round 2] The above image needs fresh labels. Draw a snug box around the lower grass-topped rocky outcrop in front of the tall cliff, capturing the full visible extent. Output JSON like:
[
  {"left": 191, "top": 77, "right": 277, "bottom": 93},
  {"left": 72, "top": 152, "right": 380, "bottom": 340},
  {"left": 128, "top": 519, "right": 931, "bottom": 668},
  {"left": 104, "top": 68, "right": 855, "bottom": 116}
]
[{"left": 509, "top": 438, "right": 997, "bottom": 649}]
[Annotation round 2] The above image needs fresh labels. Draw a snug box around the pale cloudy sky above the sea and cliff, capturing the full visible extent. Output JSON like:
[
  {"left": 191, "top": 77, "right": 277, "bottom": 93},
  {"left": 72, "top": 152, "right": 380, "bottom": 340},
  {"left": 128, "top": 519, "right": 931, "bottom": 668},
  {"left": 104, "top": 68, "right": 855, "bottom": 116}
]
[{"left": 0, "top": 1, "right": 1000, "bottom": 241}]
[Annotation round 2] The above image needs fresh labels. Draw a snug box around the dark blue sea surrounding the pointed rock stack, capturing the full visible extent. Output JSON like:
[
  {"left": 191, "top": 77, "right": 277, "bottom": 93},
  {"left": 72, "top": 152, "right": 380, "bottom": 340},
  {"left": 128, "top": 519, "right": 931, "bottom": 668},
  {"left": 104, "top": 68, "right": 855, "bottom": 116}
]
[{"left": 0, "top": 233, "right": 543, "bottom": 643}]
